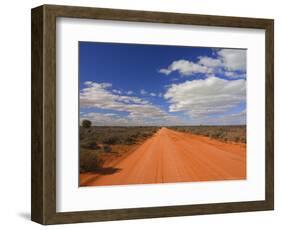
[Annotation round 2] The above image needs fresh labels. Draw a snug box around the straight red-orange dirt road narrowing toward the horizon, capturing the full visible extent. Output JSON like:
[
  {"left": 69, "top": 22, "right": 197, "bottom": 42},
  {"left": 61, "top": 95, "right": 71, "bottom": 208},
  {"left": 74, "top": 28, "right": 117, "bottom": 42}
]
[{"left": 80, "top": 128, "right": 246, "bottom": 186}]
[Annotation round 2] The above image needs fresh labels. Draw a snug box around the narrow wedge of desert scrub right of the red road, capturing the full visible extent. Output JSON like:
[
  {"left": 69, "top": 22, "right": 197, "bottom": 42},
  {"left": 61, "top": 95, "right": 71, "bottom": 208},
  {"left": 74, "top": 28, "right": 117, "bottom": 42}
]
[{"left": 169, "top": 125, "right": 246, "bottom": 143}]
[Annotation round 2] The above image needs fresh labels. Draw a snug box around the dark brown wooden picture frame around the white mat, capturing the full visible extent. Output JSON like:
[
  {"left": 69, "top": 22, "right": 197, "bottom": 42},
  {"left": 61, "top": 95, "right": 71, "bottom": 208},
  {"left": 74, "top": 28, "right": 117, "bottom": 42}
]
[{"left": 31, "top": 5, "right": 274, "bottom": 224}]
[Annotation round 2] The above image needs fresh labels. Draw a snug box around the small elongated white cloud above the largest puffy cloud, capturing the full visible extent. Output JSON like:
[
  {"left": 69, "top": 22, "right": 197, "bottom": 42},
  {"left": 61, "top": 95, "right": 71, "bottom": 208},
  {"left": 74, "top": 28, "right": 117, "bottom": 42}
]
[{"left": 159, "top": 59, "right": 212, "bottom": 76}]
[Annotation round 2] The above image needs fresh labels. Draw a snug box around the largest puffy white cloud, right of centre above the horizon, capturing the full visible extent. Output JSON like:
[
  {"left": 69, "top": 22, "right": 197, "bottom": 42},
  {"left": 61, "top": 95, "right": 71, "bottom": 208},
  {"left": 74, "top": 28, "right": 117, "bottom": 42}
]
[{"left": 164, "top": 76, "right": 246, "bottom": 118}]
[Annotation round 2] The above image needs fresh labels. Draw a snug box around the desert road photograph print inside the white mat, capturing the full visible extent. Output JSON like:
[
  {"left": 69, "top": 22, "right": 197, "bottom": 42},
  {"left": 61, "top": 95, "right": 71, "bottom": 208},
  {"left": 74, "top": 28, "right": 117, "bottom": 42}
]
[{"left": 78, "top": 41, "right": 247, "bottom": 186}]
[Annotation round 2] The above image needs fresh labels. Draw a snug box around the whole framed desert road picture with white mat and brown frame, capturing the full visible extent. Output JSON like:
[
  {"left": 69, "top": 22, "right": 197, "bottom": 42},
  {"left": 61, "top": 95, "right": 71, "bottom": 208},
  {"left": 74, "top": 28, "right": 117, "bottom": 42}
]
[{"left": 31, "top": 5, "right": 274, "bottom": 224}]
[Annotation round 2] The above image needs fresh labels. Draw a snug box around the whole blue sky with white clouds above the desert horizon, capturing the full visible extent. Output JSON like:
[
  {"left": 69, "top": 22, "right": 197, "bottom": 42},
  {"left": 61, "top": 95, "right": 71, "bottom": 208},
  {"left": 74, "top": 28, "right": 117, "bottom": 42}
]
[{"left": 79, "top": 42, "right": 246, "bottom": 126}]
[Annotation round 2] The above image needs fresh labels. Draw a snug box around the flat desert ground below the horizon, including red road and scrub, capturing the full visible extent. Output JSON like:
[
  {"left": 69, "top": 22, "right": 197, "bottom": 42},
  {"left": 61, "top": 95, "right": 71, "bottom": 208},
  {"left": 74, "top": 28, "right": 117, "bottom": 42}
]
[{"left": 80, "top": 126, "right": 246, "bottom": 186}]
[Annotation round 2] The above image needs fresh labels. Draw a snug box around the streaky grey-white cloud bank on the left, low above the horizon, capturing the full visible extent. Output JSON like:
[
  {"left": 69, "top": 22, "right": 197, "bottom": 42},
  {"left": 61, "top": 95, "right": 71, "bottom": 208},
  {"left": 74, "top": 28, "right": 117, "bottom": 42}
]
[{"left": 80, "top": 82, "right": 180, "bottom": 125}]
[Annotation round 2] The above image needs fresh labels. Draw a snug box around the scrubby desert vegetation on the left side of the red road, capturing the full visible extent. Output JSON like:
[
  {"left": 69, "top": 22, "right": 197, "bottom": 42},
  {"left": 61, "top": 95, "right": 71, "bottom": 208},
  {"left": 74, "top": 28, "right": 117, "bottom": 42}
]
[{"left": 79, "top": 121, "right": 160, "bottom": 172}]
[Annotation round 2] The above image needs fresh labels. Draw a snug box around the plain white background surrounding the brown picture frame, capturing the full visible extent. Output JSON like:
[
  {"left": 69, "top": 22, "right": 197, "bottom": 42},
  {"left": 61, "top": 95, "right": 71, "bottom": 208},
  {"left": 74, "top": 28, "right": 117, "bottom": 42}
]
[{"left": 0, "top": 0, "right": 281, "bottom": 230}]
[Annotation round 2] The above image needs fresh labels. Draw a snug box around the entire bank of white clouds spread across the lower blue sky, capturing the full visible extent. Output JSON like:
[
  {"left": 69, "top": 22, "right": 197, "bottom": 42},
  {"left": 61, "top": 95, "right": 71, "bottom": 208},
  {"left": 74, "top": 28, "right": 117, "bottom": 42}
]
[{"left": 80, "top": 49, "right": 246, "bottom": 126}]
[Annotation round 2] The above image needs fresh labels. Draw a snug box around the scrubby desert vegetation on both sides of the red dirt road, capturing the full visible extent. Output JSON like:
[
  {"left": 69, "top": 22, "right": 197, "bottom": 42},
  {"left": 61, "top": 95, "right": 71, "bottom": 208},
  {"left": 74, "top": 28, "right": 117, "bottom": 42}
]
[{"left": 79, "top": 120, "right": 246, "bottom": 173}]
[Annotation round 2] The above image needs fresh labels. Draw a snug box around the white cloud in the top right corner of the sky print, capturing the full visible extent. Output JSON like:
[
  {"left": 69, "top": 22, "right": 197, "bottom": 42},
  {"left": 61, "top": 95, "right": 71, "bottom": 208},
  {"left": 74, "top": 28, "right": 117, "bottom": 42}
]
[{"left": 217, "top": 49, "right": 247, "bottom": 71}]
